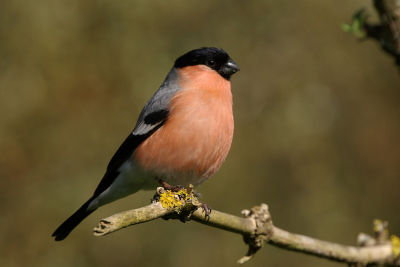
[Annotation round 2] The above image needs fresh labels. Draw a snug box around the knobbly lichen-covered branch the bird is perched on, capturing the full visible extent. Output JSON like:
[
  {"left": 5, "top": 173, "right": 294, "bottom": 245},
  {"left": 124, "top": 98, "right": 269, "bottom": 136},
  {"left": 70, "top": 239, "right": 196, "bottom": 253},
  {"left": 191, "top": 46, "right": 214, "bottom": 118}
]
[{"left": 94, "top": 187, "right": 400, "bottom": 266}]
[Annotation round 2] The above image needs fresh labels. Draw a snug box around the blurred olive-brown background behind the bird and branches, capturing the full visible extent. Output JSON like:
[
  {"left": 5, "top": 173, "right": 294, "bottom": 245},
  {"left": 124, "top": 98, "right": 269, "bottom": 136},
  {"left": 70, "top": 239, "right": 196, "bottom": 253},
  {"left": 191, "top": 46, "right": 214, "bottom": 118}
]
[{"left": 0, "top": 0, "right": 400, "bottom": 267}]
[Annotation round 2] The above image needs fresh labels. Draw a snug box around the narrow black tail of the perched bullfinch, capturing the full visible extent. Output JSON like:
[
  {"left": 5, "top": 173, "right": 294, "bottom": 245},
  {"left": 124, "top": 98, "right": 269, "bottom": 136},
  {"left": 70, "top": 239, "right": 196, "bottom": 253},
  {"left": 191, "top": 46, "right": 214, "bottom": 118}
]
[{"left": 52, "top": 198, "right": 96, "bottom": 241}]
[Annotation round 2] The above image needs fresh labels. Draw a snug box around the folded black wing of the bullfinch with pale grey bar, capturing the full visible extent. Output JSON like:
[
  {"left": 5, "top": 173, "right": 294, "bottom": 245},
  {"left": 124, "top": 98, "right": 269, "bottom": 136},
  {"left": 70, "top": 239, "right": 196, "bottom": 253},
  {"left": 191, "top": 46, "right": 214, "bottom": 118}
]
[{"left": 94, "top": 109, "right": 169, "bottom": 196}]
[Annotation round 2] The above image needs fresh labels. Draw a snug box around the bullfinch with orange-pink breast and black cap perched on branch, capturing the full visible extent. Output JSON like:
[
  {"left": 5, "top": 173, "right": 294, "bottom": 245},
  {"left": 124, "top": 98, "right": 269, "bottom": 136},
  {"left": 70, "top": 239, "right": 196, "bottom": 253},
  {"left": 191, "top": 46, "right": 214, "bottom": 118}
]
[{"left": 52, "top": 47, "right": 240, "bottom": 241}]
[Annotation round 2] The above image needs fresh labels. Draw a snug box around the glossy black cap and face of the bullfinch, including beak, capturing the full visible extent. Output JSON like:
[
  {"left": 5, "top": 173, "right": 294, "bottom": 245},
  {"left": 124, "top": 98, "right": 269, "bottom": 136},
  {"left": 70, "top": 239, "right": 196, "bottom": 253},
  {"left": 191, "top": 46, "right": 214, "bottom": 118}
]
[{"left": 174, "top": 47, "right": 240, "bottom": 81}]
